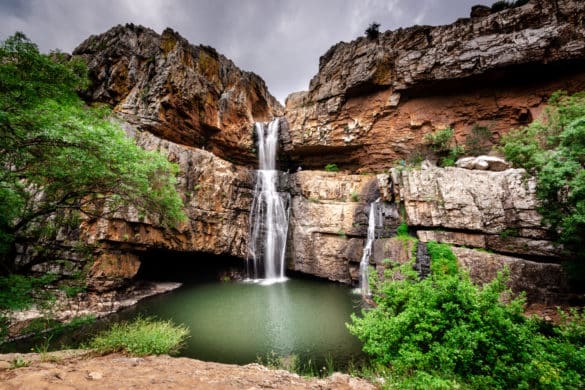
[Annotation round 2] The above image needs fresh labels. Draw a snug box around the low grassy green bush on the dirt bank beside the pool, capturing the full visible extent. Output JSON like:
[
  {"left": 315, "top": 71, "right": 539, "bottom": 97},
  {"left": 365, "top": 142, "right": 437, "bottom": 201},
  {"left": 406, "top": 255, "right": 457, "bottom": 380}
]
[{"left": 89, "top": 317, "right": 189, "bottom": 356}]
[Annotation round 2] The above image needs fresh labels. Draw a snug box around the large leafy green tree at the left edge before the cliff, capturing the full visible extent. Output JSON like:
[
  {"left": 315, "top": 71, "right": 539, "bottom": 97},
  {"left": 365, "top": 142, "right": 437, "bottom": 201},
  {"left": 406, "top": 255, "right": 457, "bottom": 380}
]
[{"left": 0, "top": 33, "right": 184, "bottom": 271}]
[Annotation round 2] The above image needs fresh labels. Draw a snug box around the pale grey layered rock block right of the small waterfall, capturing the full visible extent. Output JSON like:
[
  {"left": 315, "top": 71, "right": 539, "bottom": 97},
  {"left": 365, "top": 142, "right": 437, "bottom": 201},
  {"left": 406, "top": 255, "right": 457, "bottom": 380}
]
[{"left": 392, "top": 168, "right": 562, "bottom": 258}]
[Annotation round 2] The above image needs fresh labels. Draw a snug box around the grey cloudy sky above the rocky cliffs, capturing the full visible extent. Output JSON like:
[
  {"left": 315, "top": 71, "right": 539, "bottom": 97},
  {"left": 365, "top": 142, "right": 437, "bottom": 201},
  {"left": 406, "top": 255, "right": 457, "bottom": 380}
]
[{"left": 0, "top": 0, "right": 495, "bottom": 102}]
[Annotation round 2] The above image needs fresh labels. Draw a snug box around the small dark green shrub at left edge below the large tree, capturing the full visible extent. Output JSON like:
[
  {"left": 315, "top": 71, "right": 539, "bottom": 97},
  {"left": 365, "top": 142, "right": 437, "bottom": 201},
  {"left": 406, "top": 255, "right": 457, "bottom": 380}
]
[{"left": 0, "top": 274, "right": 57, "bottom": 310}]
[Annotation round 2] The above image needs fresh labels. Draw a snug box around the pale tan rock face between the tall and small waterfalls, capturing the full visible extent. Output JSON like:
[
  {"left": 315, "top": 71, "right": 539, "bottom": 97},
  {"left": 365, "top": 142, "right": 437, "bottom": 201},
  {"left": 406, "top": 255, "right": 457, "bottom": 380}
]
[{"left": 289, "top": 171, "right": 399, "bottom": 283}]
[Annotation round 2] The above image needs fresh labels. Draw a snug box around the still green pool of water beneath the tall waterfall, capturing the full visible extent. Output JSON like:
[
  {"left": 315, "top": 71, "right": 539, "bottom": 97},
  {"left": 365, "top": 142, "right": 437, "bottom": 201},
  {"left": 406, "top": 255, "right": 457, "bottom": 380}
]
[{"left": 120, "top": 279, "right": 361, "bottom": 364}]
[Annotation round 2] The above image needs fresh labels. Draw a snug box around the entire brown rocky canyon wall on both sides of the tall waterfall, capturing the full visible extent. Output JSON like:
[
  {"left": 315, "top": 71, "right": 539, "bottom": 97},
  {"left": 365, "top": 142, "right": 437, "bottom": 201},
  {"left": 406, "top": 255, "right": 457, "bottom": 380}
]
[{"left": 24, "top": 0, "right": 585, "bottom": 302}]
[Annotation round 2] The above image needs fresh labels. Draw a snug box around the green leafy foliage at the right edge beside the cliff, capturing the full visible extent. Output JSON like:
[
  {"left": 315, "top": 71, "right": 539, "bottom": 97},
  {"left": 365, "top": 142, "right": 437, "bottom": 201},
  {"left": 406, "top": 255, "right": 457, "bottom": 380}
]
[{"left": 502, "top": 92, "right": 585, "bottom": 258}]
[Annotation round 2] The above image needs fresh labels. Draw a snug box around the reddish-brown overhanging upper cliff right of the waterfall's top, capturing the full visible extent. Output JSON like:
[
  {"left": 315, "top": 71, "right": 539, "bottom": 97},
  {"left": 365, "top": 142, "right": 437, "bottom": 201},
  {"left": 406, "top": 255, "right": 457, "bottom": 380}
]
[{"left": 286, "top": 0, "right": 585, "bottom": 172}]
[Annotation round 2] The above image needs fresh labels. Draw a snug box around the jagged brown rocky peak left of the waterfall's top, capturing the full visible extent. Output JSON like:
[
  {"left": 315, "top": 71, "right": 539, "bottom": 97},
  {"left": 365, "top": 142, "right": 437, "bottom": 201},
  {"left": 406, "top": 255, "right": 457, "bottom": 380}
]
[{"left": 73, "top": 24, "right": 282, "bottom": 165}]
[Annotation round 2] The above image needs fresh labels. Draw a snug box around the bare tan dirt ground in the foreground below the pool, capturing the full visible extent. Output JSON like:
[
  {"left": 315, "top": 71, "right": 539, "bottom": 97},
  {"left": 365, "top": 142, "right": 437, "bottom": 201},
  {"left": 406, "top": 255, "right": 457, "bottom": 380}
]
[{"left": 0, "top": 350, "right": 376, "bottom": 390}]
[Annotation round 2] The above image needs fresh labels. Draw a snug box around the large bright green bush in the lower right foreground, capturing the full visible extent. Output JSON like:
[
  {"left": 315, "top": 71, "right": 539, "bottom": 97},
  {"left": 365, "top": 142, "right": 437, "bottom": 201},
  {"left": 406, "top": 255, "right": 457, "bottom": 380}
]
[{"left": 348, "top": 243, "right": 585, "bottom": 388}]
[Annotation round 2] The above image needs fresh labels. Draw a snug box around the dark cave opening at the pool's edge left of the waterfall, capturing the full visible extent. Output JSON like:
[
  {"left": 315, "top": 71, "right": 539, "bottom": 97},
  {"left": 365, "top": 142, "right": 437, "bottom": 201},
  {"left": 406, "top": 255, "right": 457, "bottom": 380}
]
[{"left": 135, "top": 249, "right": 246, "bottom": 283}]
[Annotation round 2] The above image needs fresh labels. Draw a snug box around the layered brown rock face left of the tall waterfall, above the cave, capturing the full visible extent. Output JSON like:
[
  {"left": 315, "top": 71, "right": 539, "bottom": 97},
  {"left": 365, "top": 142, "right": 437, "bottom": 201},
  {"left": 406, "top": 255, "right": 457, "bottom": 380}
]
[{"left": 76, "top": 124, "right": 254, "bottom": 289}]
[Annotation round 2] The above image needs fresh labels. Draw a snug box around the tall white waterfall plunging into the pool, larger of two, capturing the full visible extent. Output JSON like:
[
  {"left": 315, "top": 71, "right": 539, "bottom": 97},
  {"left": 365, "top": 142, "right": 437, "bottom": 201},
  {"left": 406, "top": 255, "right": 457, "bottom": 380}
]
[{"left": 248, "top": 118, "right": 290, "bottom": 283}]
